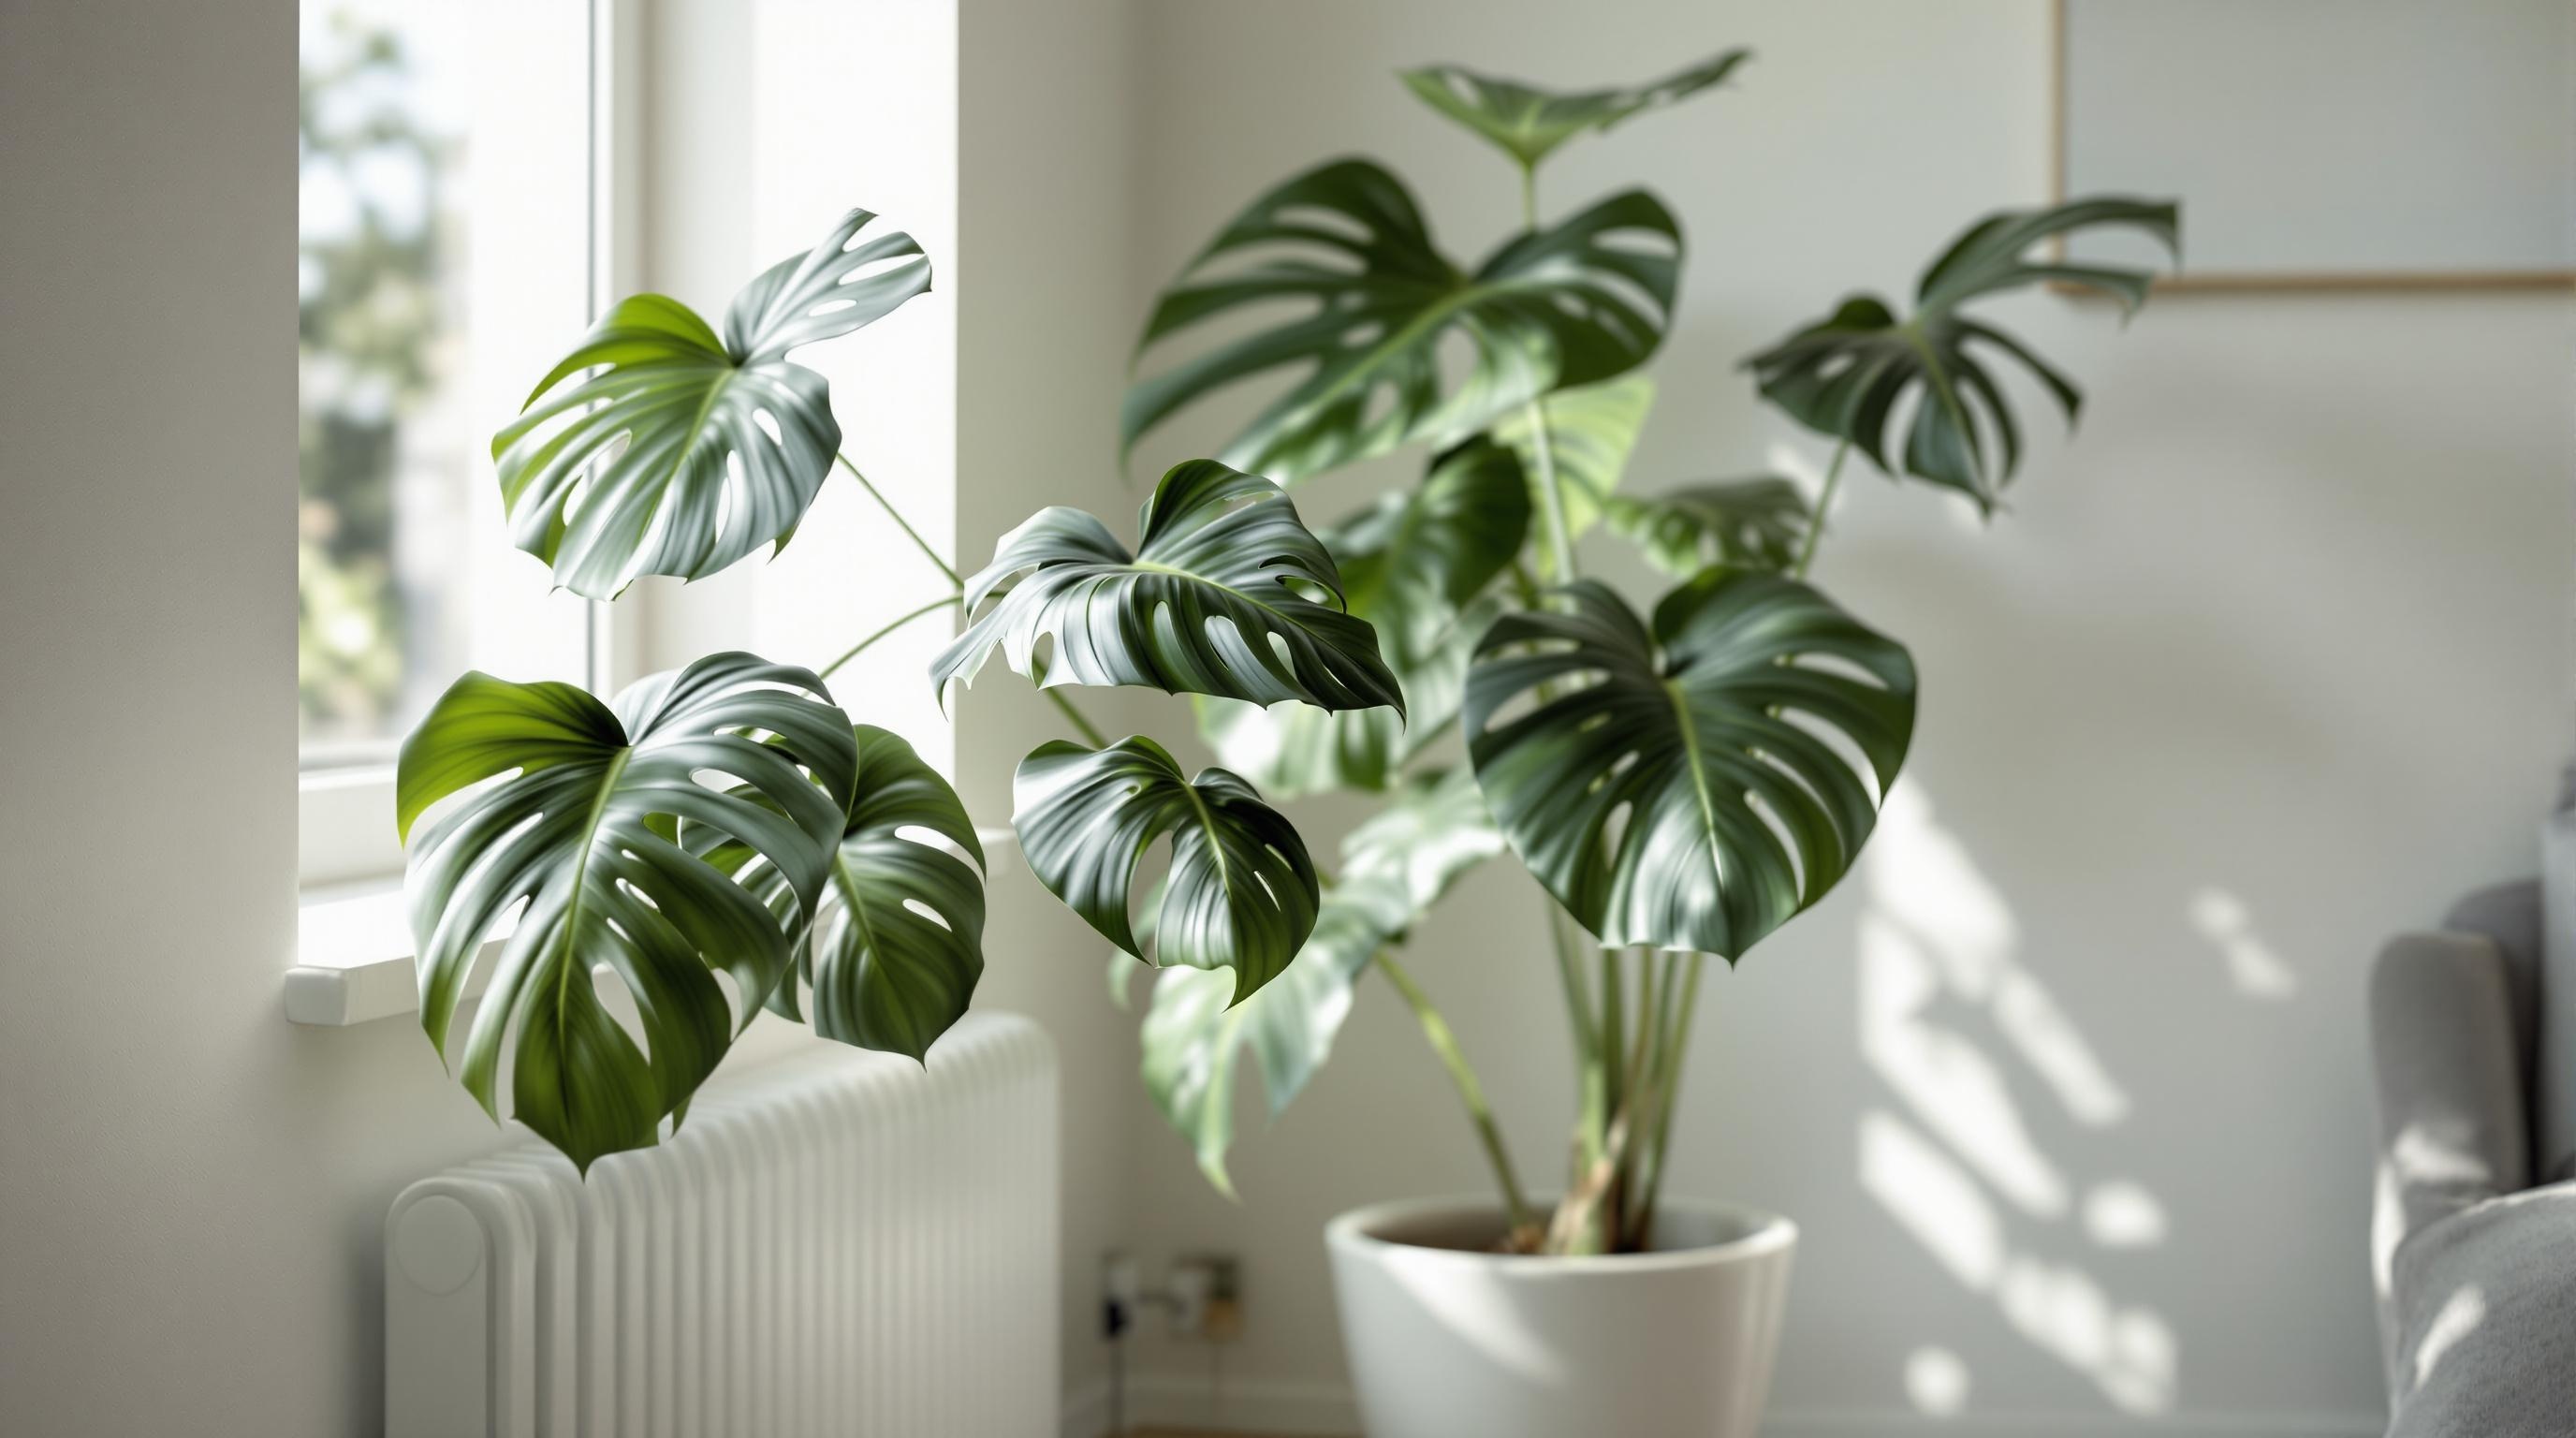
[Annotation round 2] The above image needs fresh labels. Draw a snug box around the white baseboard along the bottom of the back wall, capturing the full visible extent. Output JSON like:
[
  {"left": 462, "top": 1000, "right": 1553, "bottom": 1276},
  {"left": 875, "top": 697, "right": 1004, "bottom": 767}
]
[{"left": 1064, "top": 1373, "right": 2388, "bottom": 1438}]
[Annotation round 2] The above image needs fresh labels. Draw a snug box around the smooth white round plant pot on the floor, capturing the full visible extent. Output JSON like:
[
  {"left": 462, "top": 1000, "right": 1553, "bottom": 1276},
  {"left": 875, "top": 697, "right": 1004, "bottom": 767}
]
[{"left": 1325, "top": 1198, "right": 1798, "bottom": 1438}]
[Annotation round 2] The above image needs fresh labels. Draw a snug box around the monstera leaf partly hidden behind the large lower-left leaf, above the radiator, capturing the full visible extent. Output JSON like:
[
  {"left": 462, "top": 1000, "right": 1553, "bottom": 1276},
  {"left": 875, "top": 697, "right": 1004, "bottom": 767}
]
[{"left": 711, "top": 725, "right": 984, "bottom": 1059}]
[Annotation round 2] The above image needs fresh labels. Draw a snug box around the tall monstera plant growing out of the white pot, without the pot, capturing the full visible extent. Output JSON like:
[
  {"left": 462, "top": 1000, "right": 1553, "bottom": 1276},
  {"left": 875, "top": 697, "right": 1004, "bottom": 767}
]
[{"left": 1122, "top": 51, "right": 2176, "bottom": 1253}]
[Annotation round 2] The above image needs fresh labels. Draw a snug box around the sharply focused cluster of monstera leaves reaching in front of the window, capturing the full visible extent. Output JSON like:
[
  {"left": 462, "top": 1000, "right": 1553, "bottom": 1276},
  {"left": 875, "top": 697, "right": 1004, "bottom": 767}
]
[{"left": 397, "top": 209, "right": 1401, "bottom": 1172}]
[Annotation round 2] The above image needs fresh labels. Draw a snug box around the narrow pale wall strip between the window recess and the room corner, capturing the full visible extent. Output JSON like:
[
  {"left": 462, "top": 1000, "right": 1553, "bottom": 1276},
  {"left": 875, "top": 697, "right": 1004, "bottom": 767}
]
[{"left": 950, "top": 0, "right": 1141, "bottom": 1394}]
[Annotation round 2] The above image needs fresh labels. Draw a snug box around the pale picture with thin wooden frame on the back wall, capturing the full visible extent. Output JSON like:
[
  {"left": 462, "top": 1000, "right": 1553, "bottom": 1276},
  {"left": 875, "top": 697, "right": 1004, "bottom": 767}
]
[{"left": 2053, "top": 0, "right": 2576, "bottom": 288}]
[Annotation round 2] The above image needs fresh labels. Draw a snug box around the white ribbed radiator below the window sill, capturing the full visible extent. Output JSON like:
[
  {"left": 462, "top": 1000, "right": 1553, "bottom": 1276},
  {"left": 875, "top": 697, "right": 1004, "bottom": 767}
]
[{"left": 384, "top": 1013, "right": 1059, "bottom": 1438}]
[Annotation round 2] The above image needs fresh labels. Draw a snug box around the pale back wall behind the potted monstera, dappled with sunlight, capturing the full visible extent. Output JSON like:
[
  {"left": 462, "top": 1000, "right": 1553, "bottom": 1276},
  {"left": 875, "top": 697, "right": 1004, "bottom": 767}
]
[{"left": 1107, "top": 0, "right": 2576, "bottom": 1432}]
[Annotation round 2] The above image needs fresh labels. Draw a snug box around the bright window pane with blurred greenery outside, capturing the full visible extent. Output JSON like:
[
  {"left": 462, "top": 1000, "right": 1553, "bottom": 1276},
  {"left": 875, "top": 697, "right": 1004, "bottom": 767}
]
[{"left": 296, "top": 0, "right": 606, "bottom": 881}]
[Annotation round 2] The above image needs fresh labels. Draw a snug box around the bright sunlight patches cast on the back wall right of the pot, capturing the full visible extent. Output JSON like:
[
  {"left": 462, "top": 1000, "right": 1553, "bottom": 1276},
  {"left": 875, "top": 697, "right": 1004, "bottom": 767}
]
[{"left": 1857, "top": 784, "right": 2298, "bottom": 1415}]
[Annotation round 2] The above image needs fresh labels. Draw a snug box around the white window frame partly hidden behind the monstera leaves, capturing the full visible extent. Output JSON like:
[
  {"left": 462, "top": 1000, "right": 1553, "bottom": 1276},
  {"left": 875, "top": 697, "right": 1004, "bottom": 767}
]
[{"left": 296, "top": 0, "right": 644, "bottom": 900}]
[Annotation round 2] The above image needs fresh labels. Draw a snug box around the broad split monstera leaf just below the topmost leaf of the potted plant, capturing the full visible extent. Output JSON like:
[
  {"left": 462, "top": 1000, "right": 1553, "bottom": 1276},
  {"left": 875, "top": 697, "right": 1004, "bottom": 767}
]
[{"left": 1120, "top": 160, "right": 1682, "bottom": 482}]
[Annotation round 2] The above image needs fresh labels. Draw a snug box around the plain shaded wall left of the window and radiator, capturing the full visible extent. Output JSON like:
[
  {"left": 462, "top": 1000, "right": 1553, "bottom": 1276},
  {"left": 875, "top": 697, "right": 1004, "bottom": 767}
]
[{"left": 0, "top": 0, "right": 559, "bottom": 1438}]
